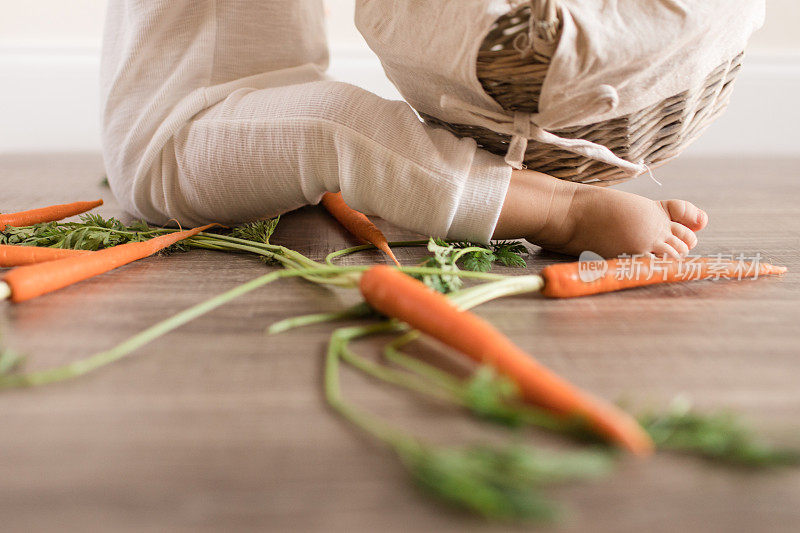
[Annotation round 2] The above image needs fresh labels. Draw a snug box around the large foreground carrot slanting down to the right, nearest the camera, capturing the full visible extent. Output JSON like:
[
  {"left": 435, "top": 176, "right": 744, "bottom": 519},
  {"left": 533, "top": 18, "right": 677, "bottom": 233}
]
[{"left": 360, "top": 265, "right": 653, "bottom": 456}]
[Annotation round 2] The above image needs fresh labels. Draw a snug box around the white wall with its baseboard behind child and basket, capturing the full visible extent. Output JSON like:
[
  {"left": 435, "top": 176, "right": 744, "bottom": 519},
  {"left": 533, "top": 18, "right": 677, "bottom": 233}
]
[{"left": 0, "top": 0, "right": 800, "bottom": 156}]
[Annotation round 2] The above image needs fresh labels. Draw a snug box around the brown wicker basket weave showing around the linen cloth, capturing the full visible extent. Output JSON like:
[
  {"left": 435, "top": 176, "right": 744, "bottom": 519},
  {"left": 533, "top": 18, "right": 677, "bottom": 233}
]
[{"left": 422, "top": 0, "right": 742, "bottom": 185}]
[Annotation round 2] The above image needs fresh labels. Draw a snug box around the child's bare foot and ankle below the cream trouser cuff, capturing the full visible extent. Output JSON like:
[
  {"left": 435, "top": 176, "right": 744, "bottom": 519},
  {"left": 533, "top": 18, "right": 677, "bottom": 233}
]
[{"left": 495, "top": 171, "right": 708, "bottom": 258}]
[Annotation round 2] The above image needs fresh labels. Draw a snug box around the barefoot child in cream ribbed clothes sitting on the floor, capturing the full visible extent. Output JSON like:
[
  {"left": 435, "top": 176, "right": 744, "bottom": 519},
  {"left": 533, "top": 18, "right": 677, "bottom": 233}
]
[{"left": 101, "top": 0, "right": 707, "bottom": 257}]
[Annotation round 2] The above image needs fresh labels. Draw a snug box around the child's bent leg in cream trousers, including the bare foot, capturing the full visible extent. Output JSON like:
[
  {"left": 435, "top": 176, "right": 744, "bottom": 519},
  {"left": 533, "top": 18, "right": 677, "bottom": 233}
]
[{"left": 173, "top": 78, "right": 707, "bottom": 257}]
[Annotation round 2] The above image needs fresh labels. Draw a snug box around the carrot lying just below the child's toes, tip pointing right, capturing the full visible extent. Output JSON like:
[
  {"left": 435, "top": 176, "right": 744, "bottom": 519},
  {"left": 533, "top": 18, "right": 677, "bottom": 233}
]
[{"left": 541, "top": 257, "right": 786, "bottom": 298}]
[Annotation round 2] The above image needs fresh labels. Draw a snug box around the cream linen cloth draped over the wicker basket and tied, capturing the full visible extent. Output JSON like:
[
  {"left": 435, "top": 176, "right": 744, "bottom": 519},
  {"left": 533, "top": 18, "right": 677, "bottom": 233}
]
[{"left": 356, "top": 0, "right": 765, "bottom": 176}]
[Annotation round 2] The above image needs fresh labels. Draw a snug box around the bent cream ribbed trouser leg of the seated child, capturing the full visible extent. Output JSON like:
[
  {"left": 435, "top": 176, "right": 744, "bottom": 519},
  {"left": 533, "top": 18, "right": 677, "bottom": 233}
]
[{"left": 170, "top": 81, "right": 511, "bottom": 242}]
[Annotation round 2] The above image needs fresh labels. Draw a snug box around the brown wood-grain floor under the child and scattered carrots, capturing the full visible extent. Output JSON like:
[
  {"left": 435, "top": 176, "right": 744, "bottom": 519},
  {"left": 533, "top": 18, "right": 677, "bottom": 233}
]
[{"left": 0, "top": 154, "right": 800, "bottom": 533}]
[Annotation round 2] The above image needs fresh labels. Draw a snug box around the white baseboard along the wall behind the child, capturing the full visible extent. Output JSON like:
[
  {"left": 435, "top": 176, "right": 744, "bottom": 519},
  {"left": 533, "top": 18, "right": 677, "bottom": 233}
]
[{"left": 0, "top": 48, "right": 800, "bottom": 157}]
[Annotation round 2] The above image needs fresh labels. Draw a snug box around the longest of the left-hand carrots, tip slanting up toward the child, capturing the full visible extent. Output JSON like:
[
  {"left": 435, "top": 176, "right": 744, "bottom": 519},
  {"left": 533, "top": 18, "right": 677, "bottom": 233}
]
[{"left": 3, "top": 224, "right": 216, "bottom": 303}]
